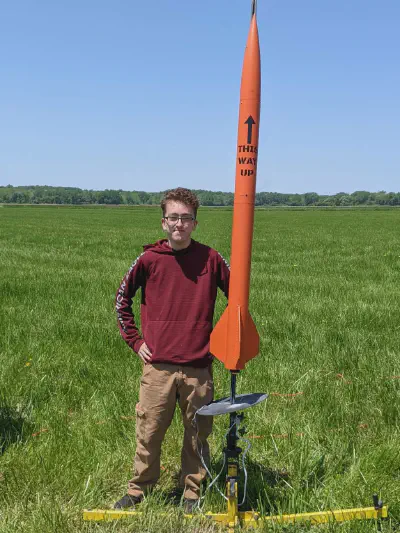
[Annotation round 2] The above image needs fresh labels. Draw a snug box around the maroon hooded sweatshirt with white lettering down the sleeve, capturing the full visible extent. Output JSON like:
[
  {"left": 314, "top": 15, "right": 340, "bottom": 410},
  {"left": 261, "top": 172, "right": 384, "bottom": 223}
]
[{"left": 116, "top": 239, "right": 229, "bottom": 367}]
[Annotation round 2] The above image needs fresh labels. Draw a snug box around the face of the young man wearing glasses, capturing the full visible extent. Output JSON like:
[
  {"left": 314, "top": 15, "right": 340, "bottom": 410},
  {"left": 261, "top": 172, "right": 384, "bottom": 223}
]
[{"left": 161, "top": 200, "right": 197, "bottom": 249}]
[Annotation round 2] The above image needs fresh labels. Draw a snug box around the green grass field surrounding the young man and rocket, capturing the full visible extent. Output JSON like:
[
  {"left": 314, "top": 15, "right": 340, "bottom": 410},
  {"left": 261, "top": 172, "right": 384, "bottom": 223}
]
[{"left": 0, "top": 206, "right": 400, "bottom": 533}]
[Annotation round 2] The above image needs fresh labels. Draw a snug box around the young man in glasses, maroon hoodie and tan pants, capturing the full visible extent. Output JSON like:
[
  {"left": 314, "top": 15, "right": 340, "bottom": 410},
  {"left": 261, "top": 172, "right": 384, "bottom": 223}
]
[{"left": 114, "top": 187, "right": 229, "bottom": 512}]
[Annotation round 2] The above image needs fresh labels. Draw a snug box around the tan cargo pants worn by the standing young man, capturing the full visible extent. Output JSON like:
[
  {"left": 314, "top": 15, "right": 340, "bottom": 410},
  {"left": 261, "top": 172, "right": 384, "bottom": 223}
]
[{"left": 128, "top": 364, "right": 214, "bottom": 499}]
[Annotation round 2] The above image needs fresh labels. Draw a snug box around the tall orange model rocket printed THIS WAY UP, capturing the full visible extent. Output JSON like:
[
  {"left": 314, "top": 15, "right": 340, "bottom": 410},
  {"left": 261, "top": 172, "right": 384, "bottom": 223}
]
[{"left": 210, "top": 0, "right": 261, "bottom": 371}]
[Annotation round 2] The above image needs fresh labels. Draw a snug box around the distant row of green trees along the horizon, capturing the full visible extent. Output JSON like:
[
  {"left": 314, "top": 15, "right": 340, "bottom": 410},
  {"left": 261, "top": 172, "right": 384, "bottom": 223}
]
[{"left": 0, "top": 185, "right": 400, "bottom": 206}]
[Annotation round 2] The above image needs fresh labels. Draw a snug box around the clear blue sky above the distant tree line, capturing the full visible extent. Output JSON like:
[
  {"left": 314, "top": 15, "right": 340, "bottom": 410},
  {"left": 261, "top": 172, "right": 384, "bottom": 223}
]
[{"left": 0, "top": 0, "right": 400, "bottom": 194}]
